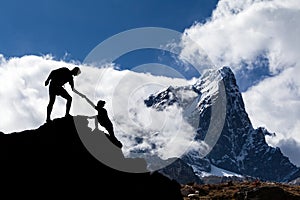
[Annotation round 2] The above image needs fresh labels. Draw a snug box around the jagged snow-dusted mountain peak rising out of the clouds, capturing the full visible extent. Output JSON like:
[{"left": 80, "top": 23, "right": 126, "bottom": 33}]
[{"left": 145, "top": 67, "right": 300, "bottom": 182}]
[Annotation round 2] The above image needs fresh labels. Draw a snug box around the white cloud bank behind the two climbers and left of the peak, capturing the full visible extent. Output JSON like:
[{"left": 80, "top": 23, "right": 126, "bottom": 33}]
[{"left": 0, "top": 55, "right": 200, "bottom": 158}]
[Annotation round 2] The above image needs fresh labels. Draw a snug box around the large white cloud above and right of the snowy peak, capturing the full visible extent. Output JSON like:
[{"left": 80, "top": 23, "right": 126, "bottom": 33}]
[{"left": 181, "top": 0, "right": 300, "bottom": 166}]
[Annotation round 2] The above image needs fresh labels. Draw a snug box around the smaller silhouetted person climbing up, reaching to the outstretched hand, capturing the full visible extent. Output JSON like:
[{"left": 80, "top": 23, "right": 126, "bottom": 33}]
[{"left": 74, "top": 89, "right": 123, "bottom": 148}]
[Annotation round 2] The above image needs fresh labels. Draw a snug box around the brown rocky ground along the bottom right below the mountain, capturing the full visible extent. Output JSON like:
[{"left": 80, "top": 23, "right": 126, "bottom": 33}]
[{"left": 181, "top": 181, "right": 300, "bottom": 200}]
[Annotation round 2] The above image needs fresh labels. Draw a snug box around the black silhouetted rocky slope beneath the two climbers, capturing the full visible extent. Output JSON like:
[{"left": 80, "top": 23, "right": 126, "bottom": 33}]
[{"left": 0, "top": 116, "right": 183, "bottom": 200}]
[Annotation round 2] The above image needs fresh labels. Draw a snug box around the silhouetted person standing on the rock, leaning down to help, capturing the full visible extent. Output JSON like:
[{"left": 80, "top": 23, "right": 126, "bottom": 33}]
[{"left": 45, "top": 67, "right": 81, "bottom": 122}]
